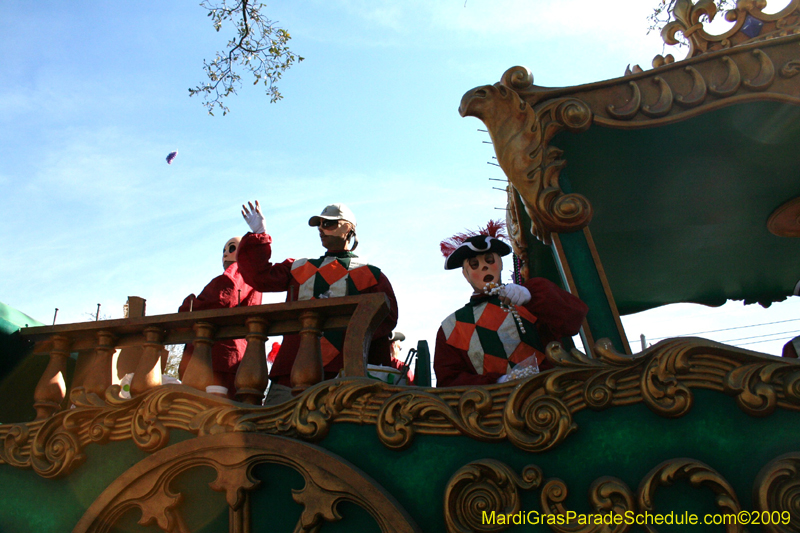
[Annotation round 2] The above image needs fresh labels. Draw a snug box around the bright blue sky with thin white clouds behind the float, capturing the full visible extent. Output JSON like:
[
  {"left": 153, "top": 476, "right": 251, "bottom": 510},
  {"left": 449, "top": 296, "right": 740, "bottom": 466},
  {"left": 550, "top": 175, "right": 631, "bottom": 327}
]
[{"left": 0, "top": 0, "right": 800, "bottom": 362}]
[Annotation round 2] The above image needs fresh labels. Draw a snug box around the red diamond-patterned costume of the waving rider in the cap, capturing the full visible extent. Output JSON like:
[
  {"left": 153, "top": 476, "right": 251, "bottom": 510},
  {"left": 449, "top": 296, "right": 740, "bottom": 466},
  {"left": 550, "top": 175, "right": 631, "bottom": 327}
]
[{"left": 238, "top": 233, "right": 397, "bottom": 386}]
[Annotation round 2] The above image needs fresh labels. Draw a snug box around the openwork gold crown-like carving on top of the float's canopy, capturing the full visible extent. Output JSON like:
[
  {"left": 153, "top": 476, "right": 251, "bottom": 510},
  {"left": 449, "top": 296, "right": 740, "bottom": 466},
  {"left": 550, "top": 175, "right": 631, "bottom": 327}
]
[{"left": 661, "top": 0, "right": 800, "bottom": 58}]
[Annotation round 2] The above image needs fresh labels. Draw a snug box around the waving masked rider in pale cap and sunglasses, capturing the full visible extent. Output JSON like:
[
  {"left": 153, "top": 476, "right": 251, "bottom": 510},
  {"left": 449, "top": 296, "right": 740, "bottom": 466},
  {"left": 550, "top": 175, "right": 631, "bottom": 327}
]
[{"left": 239, "top": 200, "right": 397, "bottom": 404}]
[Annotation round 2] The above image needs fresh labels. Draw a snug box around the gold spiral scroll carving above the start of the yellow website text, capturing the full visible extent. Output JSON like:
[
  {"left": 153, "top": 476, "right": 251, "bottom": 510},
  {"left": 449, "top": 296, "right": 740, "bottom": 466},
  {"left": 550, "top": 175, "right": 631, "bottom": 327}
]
[{"left": 444, "top": 459, "right": 542, "bottom": 533}]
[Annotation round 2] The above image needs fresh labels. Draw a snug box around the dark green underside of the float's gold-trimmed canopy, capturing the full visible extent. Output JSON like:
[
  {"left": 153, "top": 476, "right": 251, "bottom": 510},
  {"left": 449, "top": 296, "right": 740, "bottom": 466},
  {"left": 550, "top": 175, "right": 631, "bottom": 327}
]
[{"left": 552, "top": 102, "right": 800, "bottom": 314}]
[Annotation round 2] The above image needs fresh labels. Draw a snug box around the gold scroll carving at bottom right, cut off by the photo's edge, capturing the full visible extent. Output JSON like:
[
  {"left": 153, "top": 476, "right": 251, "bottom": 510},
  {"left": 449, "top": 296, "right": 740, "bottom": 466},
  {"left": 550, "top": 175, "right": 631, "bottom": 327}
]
[{"left": 753, "top": 453, "right": 800, "bottom": 533}]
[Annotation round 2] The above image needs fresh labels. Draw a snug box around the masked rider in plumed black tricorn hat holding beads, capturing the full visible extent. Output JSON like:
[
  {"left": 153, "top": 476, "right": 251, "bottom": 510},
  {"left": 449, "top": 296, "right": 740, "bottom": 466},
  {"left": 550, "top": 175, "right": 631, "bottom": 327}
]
[{"left": 433, "top": 221, "right": 589, "bottom": 387}]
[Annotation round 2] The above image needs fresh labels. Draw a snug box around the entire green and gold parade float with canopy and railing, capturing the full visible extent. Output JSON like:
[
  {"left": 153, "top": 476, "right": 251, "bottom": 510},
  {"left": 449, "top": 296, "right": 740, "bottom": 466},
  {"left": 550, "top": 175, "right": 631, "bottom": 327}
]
[{"left": 0, "top": 0, "right": 800, "bottom": 533}]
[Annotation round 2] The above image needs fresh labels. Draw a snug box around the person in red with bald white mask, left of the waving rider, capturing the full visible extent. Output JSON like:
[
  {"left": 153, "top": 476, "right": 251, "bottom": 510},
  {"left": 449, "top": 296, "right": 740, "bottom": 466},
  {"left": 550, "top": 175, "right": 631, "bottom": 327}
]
[{"left": 178, "top": 237, "right": 261, "bottom": 399}]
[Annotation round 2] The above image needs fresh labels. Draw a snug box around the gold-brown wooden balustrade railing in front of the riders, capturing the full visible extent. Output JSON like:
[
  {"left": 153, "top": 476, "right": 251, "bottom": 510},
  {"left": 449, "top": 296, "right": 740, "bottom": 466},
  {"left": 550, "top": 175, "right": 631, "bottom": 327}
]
[{"left": 20, "top": 293, "right": 389, "bottom": 420}]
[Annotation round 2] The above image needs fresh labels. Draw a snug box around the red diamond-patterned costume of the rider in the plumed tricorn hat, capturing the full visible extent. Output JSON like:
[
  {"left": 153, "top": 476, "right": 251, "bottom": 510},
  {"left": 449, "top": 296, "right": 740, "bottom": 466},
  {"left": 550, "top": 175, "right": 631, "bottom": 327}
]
[{"left": 433, "top": 278, "right": 589, "bottom": 387}]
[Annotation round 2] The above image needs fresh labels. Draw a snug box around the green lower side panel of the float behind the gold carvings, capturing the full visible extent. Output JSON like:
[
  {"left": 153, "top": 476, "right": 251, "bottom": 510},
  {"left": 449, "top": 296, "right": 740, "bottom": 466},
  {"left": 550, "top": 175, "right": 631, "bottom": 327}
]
[{"left": 0, "top": 389, "right": 800, "bottom": 533}]
